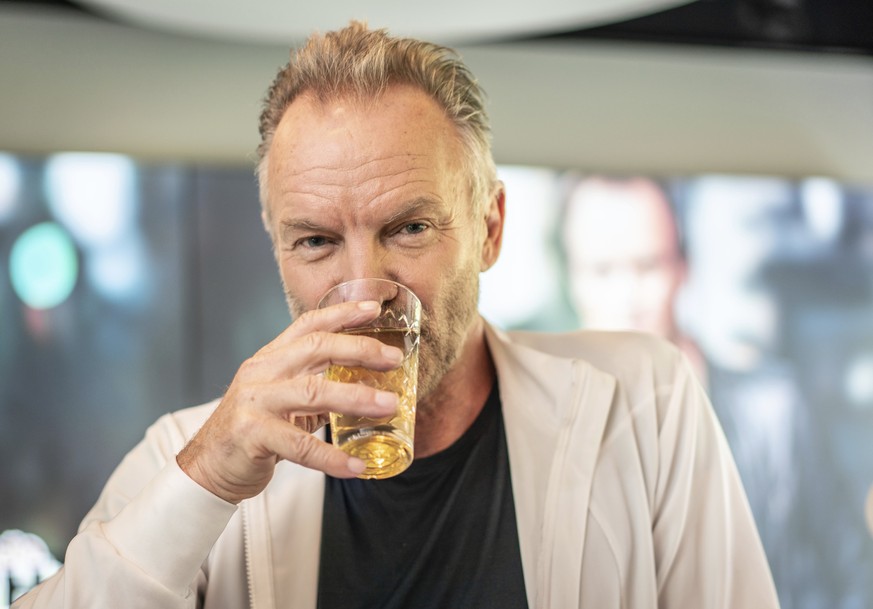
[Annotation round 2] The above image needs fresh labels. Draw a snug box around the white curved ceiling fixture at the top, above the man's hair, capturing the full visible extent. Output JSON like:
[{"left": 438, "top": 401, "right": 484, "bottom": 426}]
[{"left": 77, "top": 0, "right": 691, "bottom": 44}]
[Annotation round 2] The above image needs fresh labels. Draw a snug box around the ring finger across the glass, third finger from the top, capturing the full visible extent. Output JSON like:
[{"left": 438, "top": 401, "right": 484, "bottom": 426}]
[{"left": 252, "top": 375, "right": 399, "bottom": 419}]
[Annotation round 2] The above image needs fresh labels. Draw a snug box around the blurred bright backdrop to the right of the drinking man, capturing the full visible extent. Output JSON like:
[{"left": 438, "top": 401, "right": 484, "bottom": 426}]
[{"left": 483, "top": 167, "right": 873, "bottom": 608}]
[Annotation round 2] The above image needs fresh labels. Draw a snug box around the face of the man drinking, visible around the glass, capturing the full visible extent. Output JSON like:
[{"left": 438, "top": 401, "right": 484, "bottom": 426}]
[{"left": 268, "top": 87, "right": 484, "bottom": 398}]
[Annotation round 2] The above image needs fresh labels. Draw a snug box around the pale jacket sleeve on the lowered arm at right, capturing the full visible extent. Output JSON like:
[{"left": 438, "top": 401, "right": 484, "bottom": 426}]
[{"left": 652, "top": 356, "right": 779, "bottom": 609}]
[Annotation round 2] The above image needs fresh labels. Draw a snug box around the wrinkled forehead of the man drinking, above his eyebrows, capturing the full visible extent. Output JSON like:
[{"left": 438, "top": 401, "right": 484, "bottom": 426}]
[{"left": 268, "top": 88, "right": 469, "bottom": 223}]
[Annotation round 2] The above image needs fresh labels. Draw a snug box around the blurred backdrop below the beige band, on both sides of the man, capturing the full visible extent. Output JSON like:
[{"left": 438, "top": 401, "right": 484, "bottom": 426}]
[{"left": 0, "top": 154, "right": 873, "bottom": 609}]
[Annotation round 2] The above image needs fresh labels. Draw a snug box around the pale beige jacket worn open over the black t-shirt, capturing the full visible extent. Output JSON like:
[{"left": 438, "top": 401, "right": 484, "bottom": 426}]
[{"left": 14, "top": 320, "right": 778, "bottom": 609}]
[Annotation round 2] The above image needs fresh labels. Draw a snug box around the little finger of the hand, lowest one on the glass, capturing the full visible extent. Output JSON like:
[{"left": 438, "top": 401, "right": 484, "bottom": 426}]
[{"left": 266, "top": 423, "right": 365, "bottom": 478}]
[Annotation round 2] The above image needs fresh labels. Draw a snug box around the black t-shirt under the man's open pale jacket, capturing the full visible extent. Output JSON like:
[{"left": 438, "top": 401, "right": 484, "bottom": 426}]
[{"left": 318, "top": 384, "right": 527, "bottom": 609}]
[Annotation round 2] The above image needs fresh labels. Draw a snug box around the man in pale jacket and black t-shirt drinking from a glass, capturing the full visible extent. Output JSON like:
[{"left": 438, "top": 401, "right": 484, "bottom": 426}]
[{"left": 17, "top": 24, "right": 777, "bottom": 609}]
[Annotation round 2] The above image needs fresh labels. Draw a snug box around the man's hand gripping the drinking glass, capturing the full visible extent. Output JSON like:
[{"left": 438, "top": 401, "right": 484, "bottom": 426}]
[{"left": 176, "top": 302, "right": 403, "bottom": 503}]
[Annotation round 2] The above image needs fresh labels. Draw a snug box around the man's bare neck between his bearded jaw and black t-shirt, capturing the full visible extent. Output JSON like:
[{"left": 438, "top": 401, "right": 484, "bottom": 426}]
[{"left": 415, "top": 316, "right": 495, "bottom": 457}]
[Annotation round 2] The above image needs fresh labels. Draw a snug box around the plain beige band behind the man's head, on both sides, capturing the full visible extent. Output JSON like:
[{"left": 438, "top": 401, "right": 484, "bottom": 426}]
[{"left": 0, "top": 0, "right": 873, "bottom": 182}]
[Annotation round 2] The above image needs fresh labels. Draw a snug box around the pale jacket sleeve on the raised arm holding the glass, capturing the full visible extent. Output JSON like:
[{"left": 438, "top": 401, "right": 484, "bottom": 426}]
[{"left": 13, "top": 408, "right": 236, "bottom": 609}]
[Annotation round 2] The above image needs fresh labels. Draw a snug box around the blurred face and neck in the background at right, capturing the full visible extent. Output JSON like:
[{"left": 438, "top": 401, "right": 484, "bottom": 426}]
[{"left": 561, "top": 176, "right": 706, "bottom": 381}]
